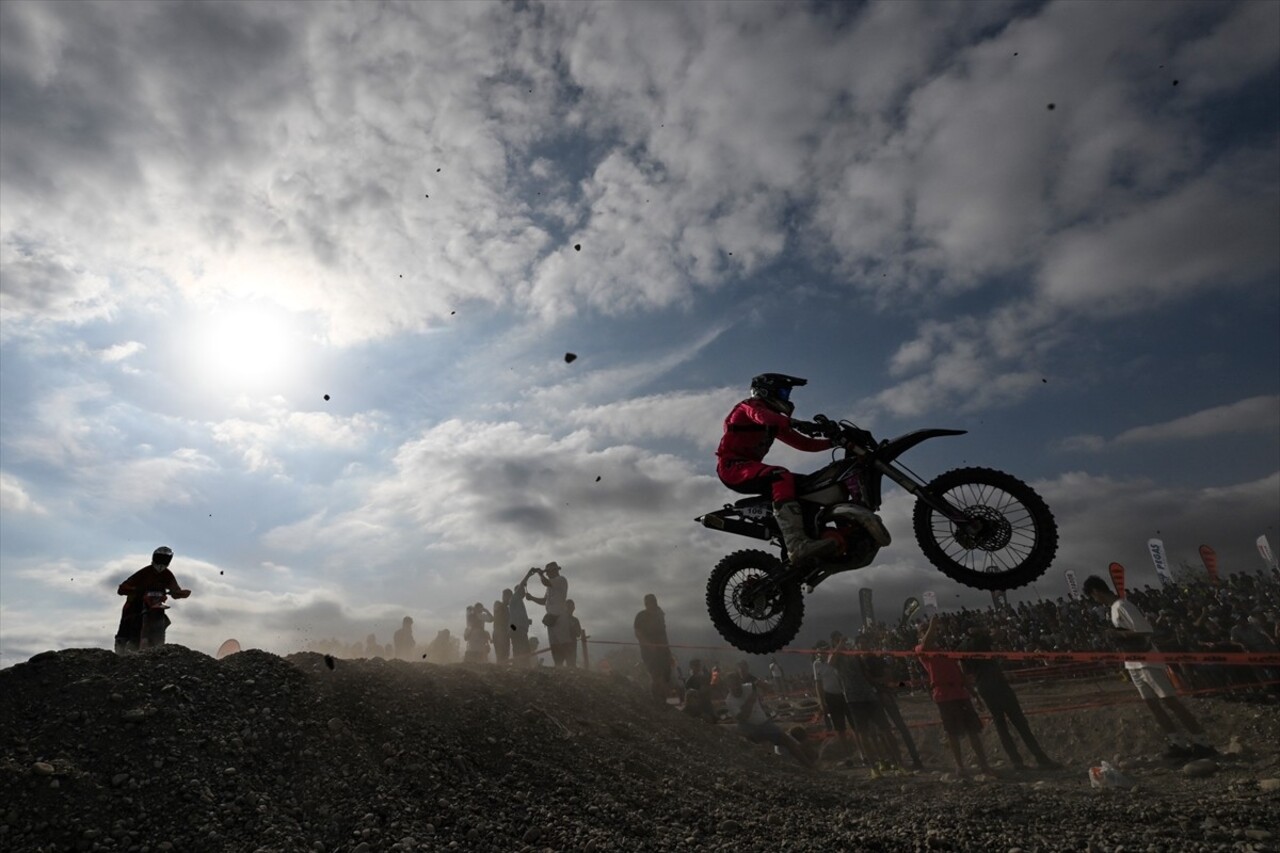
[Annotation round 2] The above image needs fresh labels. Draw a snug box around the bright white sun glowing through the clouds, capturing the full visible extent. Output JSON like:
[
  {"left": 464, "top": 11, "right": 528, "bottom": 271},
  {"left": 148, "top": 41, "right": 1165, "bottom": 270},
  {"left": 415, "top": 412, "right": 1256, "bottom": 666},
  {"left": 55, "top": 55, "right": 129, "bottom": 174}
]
[{"left": 192, "top": 302, "right": 300, "bottom": 393}]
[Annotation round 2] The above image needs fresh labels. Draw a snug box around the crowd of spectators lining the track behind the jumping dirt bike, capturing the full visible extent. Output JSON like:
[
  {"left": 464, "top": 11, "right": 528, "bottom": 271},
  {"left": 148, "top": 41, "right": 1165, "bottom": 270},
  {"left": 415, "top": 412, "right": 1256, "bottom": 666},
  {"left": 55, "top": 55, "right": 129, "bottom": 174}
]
[{"left": 302, "top": 562, "right": 1280, "bottom": 775}]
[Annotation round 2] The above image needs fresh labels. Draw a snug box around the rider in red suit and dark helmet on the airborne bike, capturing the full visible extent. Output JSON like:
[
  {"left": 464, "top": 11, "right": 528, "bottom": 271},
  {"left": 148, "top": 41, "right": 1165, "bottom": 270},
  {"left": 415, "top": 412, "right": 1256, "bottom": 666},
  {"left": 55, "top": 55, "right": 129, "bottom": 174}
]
[{"left": 716, "top": 373, "right": 878, "bottom": 565}]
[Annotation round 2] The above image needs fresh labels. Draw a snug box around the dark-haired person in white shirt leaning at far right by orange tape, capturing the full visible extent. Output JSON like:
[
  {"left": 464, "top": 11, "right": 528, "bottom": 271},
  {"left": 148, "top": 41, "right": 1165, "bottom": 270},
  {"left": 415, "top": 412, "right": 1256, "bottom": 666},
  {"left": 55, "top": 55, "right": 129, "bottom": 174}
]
[{"left": 1080, "top": 575, "right": 1217, "bottom": 758}]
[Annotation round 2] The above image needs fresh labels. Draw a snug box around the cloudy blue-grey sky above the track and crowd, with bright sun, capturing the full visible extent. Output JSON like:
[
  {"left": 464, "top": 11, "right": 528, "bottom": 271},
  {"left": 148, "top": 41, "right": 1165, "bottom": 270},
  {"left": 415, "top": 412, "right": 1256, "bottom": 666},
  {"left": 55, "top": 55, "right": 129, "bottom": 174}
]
[{"left": 0, "top": 0, "right": 1280, "bottom": 665}]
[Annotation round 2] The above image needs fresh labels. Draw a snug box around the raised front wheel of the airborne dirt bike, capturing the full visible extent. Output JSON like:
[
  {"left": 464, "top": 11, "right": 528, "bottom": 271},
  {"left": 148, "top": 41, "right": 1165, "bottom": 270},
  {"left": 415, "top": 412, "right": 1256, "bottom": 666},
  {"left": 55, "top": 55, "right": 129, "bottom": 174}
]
[{"left": 911, "top": 467, "right": 1057, "bottom": 589}]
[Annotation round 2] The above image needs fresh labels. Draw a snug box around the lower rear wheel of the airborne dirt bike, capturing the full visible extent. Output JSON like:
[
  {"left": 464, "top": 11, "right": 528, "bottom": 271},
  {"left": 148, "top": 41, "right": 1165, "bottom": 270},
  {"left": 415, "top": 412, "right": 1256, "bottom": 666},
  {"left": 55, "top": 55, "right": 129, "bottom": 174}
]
[{"left": 707, "top": 551, "right": 804, "bottom": 654}]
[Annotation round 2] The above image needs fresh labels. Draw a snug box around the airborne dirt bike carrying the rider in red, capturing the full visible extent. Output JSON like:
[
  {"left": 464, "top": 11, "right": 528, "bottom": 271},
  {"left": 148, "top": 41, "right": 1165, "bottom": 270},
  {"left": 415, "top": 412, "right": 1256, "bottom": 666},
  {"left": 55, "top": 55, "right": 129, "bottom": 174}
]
[{"left": 695, "top": 415, "right": 1057, "bottom": 654}]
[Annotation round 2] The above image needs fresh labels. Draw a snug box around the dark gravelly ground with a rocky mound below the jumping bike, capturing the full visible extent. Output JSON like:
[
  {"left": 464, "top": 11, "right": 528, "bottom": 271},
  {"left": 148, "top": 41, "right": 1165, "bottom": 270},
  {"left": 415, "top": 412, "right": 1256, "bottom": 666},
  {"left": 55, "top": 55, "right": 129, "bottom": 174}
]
[{"left": 0, "top": 646, "right": 1280, "bottom": 853}]
